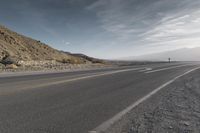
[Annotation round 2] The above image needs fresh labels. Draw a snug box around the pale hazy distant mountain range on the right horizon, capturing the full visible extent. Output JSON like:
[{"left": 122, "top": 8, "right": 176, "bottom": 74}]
[{"left": 122, "top": 47, "right": 200, "bottom": 61}]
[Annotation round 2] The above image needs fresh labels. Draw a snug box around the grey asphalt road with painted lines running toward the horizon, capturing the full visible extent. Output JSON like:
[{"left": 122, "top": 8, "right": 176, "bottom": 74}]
[{"left": 0, "top": 63, "right": 199, "bottom": 133}]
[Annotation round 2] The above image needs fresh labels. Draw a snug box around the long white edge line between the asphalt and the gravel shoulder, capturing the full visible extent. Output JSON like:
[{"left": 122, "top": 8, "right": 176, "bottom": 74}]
[{"left": 89, "top": 67, "right": 200, "bottom": 133}]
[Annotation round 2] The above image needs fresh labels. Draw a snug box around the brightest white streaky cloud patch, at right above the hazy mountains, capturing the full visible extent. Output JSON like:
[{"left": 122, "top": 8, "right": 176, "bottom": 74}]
[{"left": 143, "top": 10, "right": 200, "bottom": 42}]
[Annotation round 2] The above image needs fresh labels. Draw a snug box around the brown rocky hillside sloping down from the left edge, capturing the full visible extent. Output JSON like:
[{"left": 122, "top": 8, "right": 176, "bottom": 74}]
[{"left": 0, "top": 26, "right": 90, "bottom": 65}]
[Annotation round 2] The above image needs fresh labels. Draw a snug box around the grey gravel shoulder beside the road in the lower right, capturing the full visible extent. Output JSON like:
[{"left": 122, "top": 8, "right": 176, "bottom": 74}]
[{"left": 107, "top": 70, "right": 200, "bottom": 133}]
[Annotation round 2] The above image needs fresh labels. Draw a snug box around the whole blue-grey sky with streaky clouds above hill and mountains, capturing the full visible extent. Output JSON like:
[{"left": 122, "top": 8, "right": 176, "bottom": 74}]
[{"left": 0, "top": 0, "right": 200, "bottom": 59}]
